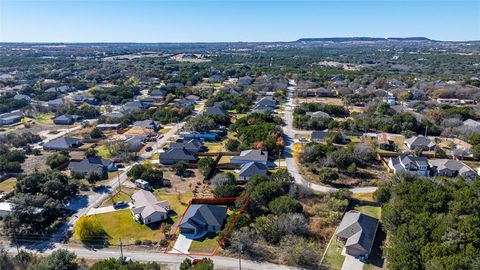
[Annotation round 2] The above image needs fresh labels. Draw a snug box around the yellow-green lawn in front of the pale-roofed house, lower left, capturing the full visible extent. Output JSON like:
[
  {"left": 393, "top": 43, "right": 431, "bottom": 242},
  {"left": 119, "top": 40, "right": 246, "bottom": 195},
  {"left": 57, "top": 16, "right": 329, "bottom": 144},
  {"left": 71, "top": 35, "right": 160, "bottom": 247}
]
[{"left": 94, "top": 209, "right": 165, "bottom": 245}]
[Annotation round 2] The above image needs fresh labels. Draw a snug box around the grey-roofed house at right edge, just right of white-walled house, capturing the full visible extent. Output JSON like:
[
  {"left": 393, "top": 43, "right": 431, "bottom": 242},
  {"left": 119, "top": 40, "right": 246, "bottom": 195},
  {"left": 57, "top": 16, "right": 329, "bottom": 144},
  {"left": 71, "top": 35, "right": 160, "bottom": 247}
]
[{"left": 428, "top": 159, "right": 478, "bottom": 178}]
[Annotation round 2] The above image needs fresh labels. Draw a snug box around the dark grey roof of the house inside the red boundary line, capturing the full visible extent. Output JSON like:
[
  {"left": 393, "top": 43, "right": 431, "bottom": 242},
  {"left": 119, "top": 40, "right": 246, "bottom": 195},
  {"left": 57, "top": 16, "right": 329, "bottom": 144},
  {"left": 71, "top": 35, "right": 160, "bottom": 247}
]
[{"left": 180, "top": 204, "right": 227, "bottom": 227}]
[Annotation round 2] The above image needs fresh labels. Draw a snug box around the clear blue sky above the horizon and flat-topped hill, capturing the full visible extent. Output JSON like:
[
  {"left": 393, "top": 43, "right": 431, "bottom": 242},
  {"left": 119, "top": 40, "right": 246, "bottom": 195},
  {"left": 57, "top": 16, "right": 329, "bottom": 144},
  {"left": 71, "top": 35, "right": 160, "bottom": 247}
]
[{"left": 0, "top": 0, "right": 480, "bottom": 42}]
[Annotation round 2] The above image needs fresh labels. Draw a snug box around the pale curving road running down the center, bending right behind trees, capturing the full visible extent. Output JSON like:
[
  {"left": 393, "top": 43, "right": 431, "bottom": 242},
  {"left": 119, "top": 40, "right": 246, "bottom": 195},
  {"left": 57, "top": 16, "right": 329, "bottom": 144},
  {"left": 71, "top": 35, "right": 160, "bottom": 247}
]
[{"left": 283, "top": 80, "right": 377, "bottom": 193}]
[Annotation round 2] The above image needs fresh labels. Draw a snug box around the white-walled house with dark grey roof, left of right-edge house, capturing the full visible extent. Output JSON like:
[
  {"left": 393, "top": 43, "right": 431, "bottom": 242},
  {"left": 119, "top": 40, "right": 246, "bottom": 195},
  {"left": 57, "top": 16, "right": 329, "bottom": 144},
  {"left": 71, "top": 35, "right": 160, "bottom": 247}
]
[{"left": 388, "top": 155, "right": 430, "bottom": 177}]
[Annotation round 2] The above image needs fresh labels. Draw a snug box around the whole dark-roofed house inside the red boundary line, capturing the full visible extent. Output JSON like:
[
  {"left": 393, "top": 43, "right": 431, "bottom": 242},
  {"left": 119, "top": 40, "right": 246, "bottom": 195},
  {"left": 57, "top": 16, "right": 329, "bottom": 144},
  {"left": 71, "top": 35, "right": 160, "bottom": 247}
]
[{"left": 179, "top": 204, "right": 227, "bottom": 239}]
